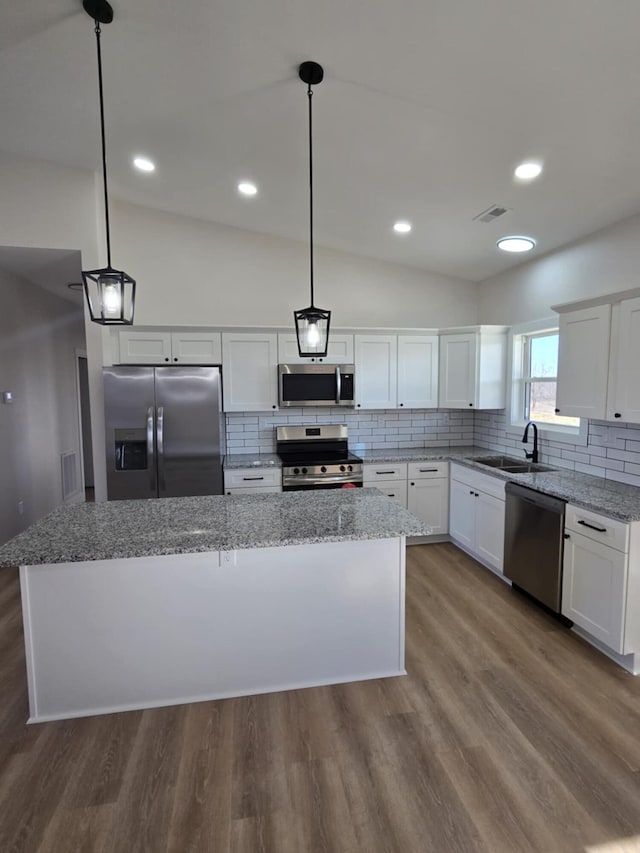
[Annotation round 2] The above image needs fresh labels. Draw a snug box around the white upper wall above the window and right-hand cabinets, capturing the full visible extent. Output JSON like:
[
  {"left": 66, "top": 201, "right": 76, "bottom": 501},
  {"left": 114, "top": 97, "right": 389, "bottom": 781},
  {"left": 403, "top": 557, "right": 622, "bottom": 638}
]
[{"left": 478, "top": 216, "right": 640, "bottom": 325}]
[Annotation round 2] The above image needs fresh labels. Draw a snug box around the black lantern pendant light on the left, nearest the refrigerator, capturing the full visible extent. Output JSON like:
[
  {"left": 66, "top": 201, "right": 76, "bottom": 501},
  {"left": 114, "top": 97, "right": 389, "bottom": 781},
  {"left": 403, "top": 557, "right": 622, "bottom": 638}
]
[{"left": 82, "top": 0, "right": 136, "bottom": 326}]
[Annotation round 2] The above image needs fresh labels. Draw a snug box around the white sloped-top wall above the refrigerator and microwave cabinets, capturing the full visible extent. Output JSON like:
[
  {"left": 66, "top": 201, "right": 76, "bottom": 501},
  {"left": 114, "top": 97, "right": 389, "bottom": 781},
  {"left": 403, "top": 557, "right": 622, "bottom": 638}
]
[{"left": 112, "top": 203, "right": 477, "bottom": 327}]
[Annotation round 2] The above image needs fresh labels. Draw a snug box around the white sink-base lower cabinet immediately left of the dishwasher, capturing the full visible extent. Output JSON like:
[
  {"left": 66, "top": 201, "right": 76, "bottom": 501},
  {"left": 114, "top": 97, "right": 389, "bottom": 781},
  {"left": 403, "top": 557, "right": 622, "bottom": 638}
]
[{"left": 449, "top": 463, "right": 505, "bottom": 574}]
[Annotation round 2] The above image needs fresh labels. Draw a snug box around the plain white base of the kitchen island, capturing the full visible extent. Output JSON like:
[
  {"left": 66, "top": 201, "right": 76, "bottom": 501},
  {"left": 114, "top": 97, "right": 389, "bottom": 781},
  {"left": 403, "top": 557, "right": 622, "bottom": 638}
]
[{"left": 20, "top": 536, "right": 405, "bottom": 723}]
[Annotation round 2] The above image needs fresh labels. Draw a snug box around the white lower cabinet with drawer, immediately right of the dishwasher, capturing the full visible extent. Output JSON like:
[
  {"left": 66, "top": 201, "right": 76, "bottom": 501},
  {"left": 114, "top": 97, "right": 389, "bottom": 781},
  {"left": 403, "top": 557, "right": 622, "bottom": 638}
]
[{"left": 562, "top": 506, "right": 635, "bottom": 654}]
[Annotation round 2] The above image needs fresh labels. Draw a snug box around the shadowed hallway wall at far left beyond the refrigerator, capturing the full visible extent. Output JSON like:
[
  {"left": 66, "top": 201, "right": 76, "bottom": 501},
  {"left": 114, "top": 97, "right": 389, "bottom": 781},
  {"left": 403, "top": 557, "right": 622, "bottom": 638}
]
[{"left": 0, "top": 270, "right": 84, "bottom": 542}]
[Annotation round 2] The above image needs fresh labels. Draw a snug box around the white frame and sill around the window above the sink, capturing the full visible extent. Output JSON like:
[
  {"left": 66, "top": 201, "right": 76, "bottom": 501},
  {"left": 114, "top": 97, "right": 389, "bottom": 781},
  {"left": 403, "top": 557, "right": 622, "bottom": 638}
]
[{"left": 506, "top": 317, "right": 588, "bottom": 446}]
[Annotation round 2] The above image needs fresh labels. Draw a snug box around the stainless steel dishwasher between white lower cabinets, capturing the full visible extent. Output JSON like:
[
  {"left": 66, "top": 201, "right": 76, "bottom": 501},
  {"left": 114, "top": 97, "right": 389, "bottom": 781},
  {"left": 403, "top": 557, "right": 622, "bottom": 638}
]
[{"left": 504, "top": 483, "right": 566, "bottom": 613}]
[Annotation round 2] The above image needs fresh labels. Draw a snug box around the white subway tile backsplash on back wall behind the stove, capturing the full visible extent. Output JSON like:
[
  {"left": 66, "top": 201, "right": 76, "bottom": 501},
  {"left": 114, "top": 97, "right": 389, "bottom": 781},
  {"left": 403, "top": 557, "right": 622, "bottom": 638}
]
[{"left": 226, "top": 407, "right": 474, "bottom": 453}]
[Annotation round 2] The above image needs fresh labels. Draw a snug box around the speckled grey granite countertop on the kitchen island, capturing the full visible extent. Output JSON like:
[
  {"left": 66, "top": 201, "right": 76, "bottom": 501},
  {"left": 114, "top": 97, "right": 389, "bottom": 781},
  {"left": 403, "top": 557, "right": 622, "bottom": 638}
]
[{"left": 0, "top": 489, "right": 430, "bottom": 567}]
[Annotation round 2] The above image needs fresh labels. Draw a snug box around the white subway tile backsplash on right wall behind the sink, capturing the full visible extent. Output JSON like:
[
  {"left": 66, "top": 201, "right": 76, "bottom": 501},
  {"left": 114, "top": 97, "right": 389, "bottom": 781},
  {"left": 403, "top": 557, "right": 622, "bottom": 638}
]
[{"left": 473, "top": 411, "right": 640, "bottom": 486}]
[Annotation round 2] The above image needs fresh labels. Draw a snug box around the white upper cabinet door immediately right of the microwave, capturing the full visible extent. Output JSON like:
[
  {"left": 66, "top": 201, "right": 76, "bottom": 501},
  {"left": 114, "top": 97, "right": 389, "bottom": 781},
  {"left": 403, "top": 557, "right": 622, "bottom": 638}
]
[{"left": 355, "top": 335, "right": 398, "bottom": 409}]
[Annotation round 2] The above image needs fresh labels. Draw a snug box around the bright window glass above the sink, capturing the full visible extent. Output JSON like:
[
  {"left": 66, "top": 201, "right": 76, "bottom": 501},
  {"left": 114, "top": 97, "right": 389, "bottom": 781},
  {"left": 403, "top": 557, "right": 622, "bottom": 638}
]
[{"left": 520, "top": 329, "right": 580, "bottom": 429}]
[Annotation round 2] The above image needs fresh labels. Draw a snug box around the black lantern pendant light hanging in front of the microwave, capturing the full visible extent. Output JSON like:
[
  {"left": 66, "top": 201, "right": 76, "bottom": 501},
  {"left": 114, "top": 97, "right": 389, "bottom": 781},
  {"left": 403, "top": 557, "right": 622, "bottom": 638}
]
[{"left": 293, "top": 62, "right": 331, "bottom": 357}]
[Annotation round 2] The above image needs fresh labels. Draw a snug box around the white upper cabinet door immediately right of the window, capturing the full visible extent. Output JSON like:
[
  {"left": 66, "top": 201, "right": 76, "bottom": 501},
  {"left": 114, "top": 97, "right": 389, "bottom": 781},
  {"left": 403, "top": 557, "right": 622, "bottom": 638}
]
[{"left": 556, "top": 305, "right": 611, "bottom": 418}]
